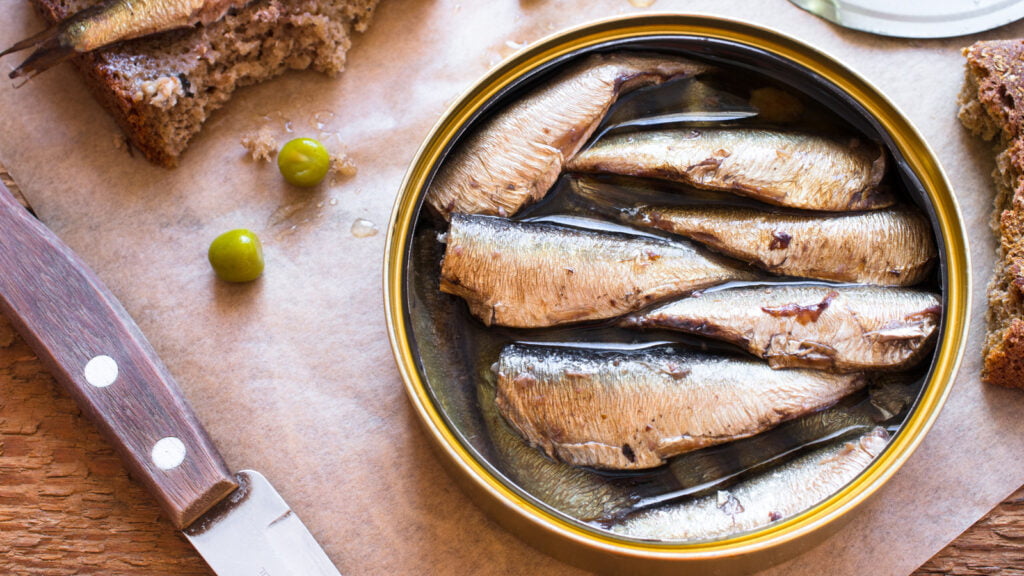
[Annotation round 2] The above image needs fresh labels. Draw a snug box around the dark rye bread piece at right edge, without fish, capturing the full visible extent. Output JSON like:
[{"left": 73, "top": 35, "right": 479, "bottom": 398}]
[{"left": 958, "top": 40, "right": 1024, "bottom": 387}]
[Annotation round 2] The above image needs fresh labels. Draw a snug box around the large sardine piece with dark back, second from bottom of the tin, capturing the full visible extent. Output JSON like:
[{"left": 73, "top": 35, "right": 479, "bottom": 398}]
[{"left": 498, "top": 344, "right": 866, "bottom": 469}]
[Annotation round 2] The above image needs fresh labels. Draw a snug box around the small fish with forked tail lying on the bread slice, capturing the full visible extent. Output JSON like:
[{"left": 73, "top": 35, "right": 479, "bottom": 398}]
[{"left": 0, "top": 0, "right": 253, "bottom": 78}]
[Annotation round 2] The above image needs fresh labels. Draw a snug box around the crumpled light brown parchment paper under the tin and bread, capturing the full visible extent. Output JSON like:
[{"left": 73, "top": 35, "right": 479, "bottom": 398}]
[{"left": 0, "top": 0, "right": 1024, "bottom": 575}]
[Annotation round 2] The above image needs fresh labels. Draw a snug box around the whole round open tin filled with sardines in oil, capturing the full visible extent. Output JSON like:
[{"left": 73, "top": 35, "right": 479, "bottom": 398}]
[{"left": 385, "top": 15, "right": 970, "bottom": 573}]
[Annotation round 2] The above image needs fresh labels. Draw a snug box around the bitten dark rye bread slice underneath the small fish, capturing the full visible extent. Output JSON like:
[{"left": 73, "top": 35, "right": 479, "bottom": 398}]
[{"left": 31, "top": 0, "right": 378, "bottom": 167}]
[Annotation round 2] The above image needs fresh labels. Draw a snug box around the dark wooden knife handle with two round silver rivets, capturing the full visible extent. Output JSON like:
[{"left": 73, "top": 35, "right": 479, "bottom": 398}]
[{"left": 0, "top": 183, "right": 237, "bottom": 529}]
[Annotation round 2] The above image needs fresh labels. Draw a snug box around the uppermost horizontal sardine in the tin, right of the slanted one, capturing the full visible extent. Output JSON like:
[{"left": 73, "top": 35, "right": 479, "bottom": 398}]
[{"left": 566, "top": 128, "right": 896, "bottom": 211}]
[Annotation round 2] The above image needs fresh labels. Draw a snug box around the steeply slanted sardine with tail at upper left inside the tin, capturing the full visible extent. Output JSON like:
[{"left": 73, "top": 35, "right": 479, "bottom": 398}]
[{"left": 427, "top": 52, "right": 708, "bottom": 218}]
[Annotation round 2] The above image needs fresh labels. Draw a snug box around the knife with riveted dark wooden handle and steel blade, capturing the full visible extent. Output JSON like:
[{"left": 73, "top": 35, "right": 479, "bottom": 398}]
[{"left": 0, "top": 183, "right": 340, "bottom": 576}]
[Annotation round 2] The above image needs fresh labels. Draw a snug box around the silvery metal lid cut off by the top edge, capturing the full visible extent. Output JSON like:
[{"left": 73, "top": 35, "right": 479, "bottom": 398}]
[{"left": 790, "top": 0, "right": 1024, "bottom": 38}]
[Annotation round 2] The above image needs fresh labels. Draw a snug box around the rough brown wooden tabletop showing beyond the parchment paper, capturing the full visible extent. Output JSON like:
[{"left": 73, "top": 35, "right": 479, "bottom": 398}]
[{"left": 0, "top": 166, "right": 1024, "bottom": 576}]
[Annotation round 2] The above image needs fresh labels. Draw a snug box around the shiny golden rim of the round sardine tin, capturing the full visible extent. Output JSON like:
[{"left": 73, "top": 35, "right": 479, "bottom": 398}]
[{"left": 384, "top": 13, "right": 971, "bottom": 561}]
